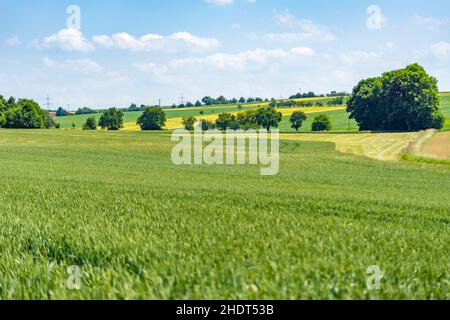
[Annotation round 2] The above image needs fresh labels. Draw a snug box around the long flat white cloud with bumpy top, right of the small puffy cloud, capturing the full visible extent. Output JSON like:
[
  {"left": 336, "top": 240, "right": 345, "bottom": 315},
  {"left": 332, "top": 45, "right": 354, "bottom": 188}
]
[{"left": 92, "top": 32, "right": 220, "bottom": 52}]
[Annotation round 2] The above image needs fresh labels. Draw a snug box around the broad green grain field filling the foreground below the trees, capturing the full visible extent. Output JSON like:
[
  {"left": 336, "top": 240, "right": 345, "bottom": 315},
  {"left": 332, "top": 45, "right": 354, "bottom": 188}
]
[{"left": 0, "top": 130, "right": 450, "bottom": 299}]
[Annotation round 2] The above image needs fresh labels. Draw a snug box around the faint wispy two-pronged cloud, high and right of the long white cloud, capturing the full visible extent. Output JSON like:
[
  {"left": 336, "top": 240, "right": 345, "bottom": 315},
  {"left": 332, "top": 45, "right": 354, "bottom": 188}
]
[{"left": 263, "top": 11, "right": 336, "bottom": 43}]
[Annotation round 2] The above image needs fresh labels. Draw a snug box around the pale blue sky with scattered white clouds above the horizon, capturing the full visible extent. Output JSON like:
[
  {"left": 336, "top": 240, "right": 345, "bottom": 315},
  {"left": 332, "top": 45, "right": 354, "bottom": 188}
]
[{"left": 0, "top": 0, "right": 450, "bottom": 108}]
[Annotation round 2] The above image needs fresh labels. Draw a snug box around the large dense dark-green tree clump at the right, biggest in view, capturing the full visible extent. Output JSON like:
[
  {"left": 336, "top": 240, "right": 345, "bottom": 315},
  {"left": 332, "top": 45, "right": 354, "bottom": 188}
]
[{"left": 347, "top": 64, "right": 445, "bottom": 131}]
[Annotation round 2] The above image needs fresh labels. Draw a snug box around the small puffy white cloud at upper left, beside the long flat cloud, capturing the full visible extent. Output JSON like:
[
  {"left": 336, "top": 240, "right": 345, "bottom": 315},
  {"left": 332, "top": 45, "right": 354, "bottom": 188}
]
[{"left": 40, "top": 28, "right": 95, "bottom": 53}]
